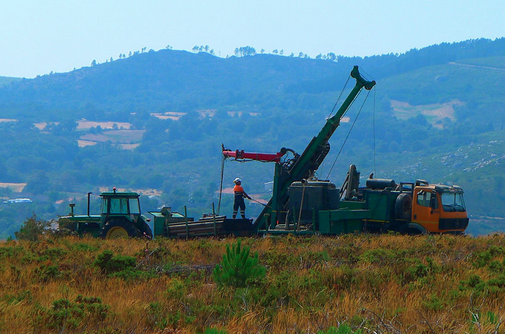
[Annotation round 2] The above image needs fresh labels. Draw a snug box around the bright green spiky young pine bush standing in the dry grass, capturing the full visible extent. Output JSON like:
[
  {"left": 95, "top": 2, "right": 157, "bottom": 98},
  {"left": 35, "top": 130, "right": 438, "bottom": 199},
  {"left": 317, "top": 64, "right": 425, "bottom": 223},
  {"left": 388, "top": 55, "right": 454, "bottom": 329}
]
[{"left": 213, "top": 240, "right": 266, "bottom": 287}]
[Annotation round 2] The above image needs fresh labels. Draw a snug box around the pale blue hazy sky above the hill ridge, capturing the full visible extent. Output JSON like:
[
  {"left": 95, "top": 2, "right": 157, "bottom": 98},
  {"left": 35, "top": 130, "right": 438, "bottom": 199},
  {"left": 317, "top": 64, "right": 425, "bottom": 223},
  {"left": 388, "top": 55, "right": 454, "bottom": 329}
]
[{"left": 0, "top": 0, "right": 505, "bottom": 78}]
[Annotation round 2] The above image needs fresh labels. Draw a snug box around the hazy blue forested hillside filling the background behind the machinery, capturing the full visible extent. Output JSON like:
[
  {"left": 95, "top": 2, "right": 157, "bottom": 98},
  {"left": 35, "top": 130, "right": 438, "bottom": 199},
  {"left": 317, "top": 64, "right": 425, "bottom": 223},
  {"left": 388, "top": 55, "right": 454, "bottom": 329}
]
[{"left": 0, "top": 38, "right": 505, "bottom": 238}]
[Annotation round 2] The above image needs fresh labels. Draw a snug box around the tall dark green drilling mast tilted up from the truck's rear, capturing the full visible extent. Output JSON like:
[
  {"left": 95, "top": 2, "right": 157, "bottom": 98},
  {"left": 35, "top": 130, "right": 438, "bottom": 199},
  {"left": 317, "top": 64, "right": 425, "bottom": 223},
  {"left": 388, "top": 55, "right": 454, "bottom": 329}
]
[{"left": 254, "top": 66, "right": 375, "bottom": 230}]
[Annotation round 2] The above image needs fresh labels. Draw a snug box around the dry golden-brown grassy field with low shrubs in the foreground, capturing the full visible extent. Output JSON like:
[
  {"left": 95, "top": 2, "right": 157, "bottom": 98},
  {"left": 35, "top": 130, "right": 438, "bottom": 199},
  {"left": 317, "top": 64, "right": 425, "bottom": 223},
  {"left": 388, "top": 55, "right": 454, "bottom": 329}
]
[{"left": 0, "top": 235, "right": 505, "bottom": 333}]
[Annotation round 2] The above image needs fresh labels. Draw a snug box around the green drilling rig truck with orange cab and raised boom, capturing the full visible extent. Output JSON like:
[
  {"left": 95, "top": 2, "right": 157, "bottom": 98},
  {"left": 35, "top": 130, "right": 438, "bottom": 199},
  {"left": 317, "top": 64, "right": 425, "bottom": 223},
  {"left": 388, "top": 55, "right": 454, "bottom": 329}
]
[{"left": 233, "top": 66, "right": 468, "bottom": 234}]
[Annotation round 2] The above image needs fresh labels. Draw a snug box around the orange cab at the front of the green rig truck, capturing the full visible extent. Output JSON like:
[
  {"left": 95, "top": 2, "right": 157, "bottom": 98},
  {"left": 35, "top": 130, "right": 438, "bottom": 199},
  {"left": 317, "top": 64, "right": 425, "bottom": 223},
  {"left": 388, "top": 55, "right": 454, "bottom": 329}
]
[{"left": 409, "top": 182, "right": 469, "bottom": 234}]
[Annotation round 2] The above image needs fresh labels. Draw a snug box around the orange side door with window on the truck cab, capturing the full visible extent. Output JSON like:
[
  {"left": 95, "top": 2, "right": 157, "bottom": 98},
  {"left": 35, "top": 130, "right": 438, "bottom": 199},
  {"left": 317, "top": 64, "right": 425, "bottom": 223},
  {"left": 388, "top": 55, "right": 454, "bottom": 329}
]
[{"left": 412, "top": 189, "right": 440, "bottom": 232}]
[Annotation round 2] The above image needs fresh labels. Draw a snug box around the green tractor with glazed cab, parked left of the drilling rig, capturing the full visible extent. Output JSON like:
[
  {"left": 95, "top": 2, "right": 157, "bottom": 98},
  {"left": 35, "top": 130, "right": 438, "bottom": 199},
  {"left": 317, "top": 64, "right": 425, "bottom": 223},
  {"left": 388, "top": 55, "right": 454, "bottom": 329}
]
[{"left": 58, "top": 188, "right": 153, "bottom": 239}]
